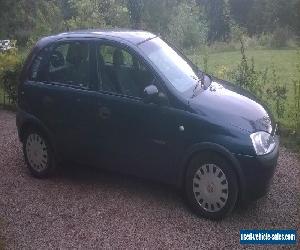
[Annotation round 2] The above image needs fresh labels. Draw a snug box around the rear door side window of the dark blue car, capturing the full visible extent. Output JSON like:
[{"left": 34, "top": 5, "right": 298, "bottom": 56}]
[{"left": 47, "top": 41, "right": 90, "bottom": 87}]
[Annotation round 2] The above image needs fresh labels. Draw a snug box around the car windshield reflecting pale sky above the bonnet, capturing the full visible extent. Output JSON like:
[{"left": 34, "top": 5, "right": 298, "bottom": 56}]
[{"left": 140, "top": 37, "right": 200, "bottom": 92}]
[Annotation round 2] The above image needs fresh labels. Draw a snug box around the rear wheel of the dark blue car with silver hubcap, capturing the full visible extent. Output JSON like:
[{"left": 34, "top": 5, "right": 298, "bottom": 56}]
[{"left": 23, "top": 129, "right": 55, "bottom": 178}]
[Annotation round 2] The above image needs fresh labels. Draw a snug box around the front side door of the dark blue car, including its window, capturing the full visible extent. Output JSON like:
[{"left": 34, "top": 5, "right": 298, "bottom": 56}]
[{"left": 92, "top": 42, "right": 181, "bottom": 180}]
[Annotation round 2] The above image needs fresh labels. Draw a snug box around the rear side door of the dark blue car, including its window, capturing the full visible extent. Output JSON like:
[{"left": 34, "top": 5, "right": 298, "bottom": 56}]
[{"left": 27, "top": 39, "right": 95, "bottom": 163}]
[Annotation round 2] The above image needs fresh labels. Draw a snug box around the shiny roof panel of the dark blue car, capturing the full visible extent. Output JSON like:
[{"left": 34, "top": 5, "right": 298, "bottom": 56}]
[{"left": 41, "top": 29, "right": 156, "bottom": 45}]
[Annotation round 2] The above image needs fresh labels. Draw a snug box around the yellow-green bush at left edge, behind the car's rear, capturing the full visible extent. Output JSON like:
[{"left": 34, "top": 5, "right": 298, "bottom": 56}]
[{"left": 0, "top": 50, "right": 23, "bottom": 104}]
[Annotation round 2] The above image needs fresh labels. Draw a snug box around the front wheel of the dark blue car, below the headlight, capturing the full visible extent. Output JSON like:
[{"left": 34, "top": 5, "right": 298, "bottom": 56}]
[{"left": 185, "top": 153, "right": 238, "bottom": 220}]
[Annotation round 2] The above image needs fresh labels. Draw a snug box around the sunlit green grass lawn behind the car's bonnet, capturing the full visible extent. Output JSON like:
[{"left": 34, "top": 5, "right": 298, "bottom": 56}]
[{"left": 189, "top": 50, "right": 300, "bottom": 98}]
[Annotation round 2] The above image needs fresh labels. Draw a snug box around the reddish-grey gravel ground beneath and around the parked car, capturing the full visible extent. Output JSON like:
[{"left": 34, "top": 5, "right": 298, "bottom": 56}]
[{"left": 0, "top": 110, "right": 300, "bottom": 249}]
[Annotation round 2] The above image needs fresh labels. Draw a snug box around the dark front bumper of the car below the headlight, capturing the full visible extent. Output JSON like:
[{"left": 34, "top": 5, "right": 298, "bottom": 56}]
[{"left": 235, "top": 136, "right": 279, "bottom": 202}]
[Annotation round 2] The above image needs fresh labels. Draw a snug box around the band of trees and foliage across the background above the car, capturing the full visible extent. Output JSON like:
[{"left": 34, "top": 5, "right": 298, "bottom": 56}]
[{"left": 0, "top": 0, "right": 300, "bottom": 48}]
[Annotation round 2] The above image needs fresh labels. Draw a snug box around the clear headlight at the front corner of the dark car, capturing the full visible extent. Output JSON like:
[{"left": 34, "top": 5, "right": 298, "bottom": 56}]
[{"left": 250, "top": 131, "right": 276, "bottom": 155}]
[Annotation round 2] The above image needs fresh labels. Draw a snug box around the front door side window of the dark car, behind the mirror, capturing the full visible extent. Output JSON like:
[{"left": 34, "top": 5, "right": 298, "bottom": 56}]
[{"left": 98, "top": 44, "right": 154, "bottom": 97}]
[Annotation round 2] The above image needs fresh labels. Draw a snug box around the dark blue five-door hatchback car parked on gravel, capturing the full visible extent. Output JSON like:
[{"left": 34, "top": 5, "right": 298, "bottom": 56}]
[{"left": 17, "top": 30, "right": 279, "bottom": 219}]
